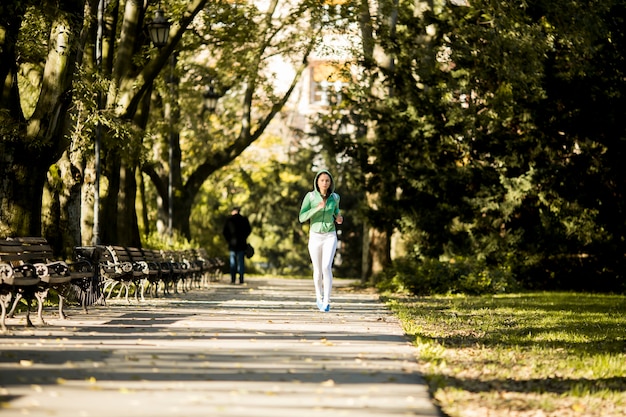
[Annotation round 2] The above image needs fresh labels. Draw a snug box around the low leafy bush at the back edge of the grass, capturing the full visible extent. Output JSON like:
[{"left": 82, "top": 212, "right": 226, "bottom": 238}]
[{"left": 378, "top": 258, "right": 517, "bottom": 295}]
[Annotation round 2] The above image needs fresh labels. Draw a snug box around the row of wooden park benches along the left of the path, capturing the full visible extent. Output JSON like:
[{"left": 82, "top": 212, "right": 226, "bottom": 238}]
[{"left": 0, "top": 237, "right": 224, "bottom": 331}]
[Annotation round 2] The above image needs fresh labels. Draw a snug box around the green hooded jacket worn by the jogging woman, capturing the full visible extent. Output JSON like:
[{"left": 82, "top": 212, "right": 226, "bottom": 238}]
[{"left": 299, "top": 170, "right": 339, "bottom": 233}]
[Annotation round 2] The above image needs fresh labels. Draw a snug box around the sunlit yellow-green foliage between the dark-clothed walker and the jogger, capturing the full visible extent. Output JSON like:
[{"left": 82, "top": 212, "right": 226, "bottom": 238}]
[{"left": 186, "top": 135, "right": 312, "bottom": 274}]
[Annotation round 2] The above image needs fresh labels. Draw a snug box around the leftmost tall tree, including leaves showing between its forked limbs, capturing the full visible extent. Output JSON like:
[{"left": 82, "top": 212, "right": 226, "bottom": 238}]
[{"left": 0, "top": 0, "right": 84, "bottom": 239}]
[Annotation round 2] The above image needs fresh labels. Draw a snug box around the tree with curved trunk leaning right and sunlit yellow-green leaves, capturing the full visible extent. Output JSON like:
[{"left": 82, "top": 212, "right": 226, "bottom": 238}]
[{"left": 143, "top": 0, "right": 323, "bottom": 238}]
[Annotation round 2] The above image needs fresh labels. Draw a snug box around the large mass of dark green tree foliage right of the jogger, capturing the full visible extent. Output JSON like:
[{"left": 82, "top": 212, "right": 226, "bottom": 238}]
[{"left": 335, "top": 0, "right": 626, "bottom": 292}]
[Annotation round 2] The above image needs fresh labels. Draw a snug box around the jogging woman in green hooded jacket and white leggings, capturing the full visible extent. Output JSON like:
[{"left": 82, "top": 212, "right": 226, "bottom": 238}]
[{"left": 299, "top": 170, "right": 343, "bottom": 311}]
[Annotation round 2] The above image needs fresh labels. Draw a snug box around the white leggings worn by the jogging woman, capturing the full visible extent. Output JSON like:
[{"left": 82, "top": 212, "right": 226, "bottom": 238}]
[{"left": 309, "top": 232, "right": 337, "bottom": 304}]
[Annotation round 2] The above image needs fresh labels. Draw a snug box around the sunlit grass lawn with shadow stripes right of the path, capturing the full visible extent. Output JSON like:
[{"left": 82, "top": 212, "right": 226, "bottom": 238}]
[{"left": 388, "top": 293, "right": 626, "bottom": 417}]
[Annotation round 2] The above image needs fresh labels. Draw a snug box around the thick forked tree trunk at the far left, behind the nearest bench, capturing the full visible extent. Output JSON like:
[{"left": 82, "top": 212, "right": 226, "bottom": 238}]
[{"left": 0, "top": 2, "right": 83, "bottom": 236}]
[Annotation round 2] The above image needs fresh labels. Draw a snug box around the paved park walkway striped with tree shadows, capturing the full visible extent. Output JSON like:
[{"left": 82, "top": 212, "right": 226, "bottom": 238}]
[{"left": 0, "top": 277, "right": 440, "bottom": 417}]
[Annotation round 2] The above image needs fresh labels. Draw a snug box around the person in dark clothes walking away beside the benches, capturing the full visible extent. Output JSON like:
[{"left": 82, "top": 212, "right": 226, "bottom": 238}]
[{"left": 222, "top": 207, "right": 252, "bottom": 284}]
